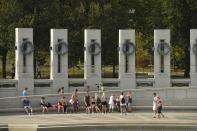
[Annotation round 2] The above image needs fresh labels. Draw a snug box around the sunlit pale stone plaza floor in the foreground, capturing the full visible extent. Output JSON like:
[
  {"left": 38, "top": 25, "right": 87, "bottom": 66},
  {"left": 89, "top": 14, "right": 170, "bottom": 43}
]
[{"left": 0, "top": 111, "right": 197, "bottom": 131}]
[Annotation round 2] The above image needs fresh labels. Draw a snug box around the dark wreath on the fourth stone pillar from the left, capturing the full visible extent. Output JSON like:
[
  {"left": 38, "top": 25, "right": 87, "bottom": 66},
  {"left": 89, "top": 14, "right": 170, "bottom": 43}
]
[{"left": 122, "top": 40, "right": 135, "bottom": 55}]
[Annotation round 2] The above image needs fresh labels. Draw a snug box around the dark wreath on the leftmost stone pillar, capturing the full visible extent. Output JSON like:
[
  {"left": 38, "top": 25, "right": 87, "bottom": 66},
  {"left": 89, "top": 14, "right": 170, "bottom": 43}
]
[{"left": 20, "top": 39, "right": 34, "bottom": 55}]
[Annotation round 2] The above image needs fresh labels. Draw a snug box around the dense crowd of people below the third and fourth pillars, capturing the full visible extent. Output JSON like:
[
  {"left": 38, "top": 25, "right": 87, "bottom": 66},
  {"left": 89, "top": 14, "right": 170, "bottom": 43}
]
[{"left": 84, "top": 91, "right": 132, "bottom": 114}]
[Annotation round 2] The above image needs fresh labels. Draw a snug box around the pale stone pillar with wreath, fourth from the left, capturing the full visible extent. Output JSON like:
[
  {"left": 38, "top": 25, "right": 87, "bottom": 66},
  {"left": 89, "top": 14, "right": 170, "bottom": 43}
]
[{"left": 119, "top": 30, "right": 136, "bottom": 89}]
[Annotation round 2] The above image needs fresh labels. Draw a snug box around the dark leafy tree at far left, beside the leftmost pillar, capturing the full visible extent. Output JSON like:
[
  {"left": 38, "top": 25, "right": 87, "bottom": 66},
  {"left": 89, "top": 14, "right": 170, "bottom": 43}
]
[{"left": 0, "top": 0, "right": 18, "bottom": 78}]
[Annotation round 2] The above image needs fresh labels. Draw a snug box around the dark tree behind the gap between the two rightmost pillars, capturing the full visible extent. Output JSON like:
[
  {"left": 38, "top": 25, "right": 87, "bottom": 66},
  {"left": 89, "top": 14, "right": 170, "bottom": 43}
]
[{"left": 163, "top": 0, "right": 197, "bottom": 77}]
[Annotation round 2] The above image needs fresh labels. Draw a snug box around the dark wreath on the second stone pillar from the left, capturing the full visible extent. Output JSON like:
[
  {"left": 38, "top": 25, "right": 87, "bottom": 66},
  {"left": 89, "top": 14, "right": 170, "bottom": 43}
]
[{"left": 55, "top": 41, "right": 68, "bottom": 55}]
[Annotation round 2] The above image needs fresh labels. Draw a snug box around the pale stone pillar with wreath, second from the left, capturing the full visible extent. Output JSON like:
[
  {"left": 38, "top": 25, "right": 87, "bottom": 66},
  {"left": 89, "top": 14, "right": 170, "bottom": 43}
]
[{"left": 50, "top": 29, "right": 68, "bottom": 93}]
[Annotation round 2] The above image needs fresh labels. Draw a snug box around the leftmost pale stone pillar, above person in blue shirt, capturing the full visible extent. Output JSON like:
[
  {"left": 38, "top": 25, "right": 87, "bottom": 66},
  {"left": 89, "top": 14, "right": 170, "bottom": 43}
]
[{"left": 15, "top": 28, "right": 34, "bottom": 95}]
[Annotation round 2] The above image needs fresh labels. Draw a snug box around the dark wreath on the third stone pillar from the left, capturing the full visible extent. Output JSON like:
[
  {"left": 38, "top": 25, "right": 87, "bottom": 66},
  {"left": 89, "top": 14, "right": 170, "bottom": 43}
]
[{"left": 88, "top": 41, "right": 101, "bottom": 56}]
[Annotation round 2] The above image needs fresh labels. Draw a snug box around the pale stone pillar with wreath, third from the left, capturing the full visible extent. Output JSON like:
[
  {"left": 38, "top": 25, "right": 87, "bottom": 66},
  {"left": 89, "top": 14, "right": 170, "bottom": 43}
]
[{"left": 84, "top": 29, "right": 101, "bottom": 90}]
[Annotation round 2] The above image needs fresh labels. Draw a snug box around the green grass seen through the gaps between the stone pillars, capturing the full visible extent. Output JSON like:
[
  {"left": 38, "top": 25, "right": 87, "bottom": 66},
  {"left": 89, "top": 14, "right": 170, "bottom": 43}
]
[{"left": 0, "top": 64, "right": 184, "bottom": 79}]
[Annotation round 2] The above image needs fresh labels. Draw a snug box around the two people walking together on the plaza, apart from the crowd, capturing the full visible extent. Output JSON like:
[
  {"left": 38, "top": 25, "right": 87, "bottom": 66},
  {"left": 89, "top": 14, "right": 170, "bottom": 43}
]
[{"left": 153, "top": 92, "right": 164, "bottom": 118}]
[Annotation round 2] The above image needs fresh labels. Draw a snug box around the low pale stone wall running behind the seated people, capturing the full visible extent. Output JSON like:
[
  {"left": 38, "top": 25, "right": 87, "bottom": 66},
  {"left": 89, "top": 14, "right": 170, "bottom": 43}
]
[{"left": 0, "top": 87, "right": 197, "bottom": 110}]
